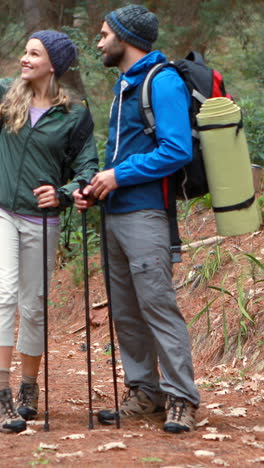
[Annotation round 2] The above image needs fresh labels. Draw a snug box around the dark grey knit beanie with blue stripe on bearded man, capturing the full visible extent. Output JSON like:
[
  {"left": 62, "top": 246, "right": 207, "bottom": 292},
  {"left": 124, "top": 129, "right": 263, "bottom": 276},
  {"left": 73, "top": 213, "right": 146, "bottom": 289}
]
[{"left": 105, "top": 5, "right": 159, "bottom": 52}]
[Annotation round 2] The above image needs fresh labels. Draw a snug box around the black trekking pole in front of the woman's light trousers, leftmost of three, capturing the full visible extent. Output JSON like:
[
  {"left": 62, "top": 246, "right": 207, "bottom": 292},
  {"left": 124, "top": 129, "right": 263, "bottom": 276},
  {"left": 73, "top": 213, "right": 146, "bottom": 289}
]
[{"left": 39, "top": 180, "right": 50, "bottom": 432}]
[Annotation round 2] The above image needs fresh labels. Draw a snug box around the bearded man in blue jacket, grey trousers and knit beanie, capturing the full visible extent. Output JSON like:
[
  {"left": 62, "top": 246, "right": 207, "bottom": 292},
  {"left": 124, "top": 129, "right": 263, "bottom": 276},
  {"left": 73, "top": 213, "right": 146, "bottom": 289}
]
[{"left": 75, "top": 5, "right": 199, "bottom": 433}]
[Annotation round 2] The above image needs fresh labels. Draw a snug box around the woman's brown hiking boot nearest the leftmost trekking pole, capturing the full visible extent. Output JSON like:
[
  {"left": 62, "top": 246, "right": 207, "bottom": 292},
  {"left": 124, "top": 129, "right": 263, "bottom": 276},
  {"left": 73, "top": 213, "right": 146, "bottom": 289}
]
[{"left": 16, "top": 382, "right": 39, "bottom": 421}]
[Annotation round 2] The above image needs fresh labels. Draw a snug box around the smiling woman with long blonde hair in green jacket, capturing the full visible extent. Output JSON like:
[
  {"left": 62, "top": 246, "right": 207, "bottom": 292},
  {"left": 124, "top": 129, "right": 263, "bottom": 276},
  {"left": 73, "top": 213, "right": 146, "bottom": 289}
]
[{"left": 0, "top": 30, "right": 98, "bottom": 432}]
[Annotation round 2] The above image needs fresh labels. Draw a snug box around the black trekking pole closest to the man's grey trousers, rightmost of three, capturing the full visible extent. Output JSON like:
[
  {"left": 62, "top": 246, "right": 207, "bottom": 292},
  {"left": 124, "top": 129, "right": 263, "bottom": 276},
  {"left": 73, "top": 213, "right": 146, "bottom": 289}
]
[{"left": 100, "top": 202, "right": 120, "bottom": 429}]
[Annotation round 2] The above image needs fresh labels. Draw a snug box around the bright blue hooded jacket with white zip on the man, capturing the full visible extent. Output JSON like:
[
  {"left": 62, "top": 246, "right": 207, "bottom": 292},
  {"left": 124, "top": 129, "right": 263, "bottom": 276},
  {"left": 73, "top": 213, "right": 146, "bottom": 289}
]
[{"left": 105, "top": 51, "right": 192, "bottom": 213}]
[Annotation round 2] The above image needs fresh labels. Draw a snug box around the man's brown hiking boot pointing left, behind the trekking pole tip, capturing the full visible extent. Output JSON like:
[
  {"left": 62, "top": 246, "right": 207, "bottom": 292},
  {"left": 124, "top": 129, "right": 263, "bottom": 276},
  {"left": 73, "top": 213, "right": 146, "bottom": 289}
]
[{"left": 98, "top": 389, "right": 164, "bottom": 424}]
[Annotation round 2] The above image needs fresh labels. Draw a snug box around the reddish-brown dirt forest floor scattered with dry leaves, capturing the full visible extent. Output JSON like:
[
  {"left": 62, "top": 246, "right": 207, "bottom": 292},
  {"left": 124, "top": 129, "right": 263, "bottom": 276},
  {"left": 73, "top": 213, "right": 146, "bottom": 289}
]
[{"left": 0, "top": 203, "right": 264, "bottom": 468}]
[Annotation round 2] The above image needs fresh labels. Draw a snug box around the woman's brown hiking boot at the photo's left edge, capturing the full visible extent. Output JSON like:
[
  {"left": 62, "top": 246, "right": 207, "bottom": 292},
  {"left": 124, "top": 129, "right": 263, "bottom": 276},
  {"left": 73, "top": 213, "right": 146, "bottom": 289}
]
[{"left": 0, "top": 388, "right": 27, "bottom": 433}]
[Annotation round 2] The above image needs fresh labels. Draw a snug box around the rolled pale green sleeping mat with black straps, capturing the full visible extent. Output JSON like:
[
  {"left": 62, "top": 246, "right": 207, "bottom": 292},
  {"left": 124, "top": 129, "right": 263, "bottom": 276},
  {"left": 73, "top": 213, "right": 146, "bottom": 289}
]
[{"left": 197, "top": 97, "right": 261, "bottom": 236}]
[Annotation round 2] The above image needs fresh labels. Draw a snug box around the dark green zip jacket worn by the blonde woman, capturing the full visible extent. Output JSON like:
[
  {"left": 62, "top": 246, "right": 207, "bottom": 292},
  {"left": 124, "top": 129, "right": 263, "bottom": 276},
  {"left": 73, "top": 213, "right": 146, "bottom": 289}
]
[{"left": 0, "top": 79, "right": 98, "bottom": 216}]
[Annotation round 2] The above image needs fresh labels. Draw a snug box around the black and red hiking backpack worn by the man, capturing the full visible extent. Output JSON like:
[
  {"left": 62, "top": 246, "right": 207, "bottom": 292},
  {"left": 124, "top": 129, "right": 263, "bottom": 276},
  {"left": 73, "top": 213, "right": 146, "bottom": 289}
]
[{"left": 139, "top": 51, "right": 231, "bottom": 263}]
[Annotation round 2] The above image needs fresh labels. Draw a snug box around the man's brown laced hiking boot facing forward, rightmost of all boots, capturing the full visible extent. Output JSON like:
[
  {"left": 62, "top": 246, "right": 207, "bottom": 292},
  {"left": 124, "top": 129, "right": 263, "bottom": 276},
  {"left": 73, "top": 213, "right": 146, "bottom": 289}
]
[{"left": 163, "top": 395, "right": 196, "bottom": 433}]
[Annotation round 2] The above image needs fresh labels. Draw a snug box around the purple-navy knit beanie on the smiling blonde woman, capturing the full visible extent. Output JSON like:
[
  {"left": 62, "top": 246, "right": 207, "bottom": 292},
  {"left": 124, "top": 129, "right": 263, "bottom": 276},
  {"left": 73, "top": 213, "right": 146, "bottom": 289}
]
[{"left": 29, "top": 29, "right": 77, "bottom": 78}]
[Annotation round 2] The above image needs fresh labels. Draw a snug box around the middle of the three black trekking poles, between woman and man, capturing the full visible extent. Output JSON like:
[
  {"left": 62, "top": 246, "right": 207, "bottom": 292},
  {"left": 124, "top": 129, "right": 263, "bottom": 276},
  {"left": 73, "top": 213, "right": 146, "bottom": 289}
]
[{"left": 79, "top": 180, "right": 94, "bottom": 429}]
